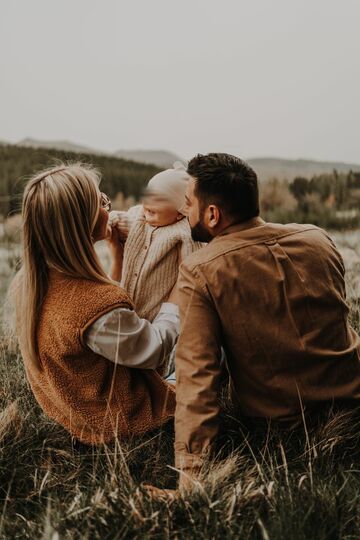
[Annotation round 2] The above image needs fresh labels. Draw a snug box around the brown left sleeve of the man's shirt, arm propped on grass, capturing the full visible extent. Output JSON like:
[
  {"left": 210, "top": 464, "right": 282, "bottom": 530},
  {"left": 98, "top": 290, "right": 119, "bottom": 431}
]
[{"left": 175, "top": 263, "right": 221, "bottom": 472}]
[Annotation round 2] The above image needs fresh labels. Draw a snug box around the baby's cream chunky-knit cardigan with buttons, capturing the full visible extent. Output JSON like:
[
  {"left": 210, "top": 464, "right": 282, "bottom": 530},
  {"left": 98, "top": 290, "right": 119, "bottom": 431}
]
[{"left": 121, "top": 205, "right": 203, "bottom": 321}]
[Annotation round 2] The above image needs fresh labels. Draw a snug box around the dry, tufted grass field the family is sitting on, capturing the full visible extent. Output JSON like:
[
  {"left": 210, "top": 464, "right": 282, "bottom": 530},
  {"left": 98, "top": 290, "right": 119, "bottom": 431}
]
[{"left": 0, "top": 232, "right": 360, "bottom": 540}]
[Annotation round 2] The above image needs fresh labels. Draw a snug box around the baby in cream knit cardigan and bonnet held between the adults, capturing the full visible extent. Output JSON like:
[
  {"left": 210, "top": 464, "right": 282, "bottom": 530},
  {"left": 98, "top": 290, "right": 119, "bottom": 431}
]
[{"left": 110, "top": 161, "right": 203, "bottom": 321}]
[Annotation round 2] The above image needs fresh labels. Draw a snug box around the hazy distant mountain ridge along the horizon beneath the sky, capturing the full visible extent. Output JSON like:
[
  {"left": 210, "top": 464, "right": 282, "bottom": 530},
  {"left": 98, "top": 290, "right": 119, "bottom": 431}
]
[{"left": 9, "top": 138, "right": 360, "bottom": 181}]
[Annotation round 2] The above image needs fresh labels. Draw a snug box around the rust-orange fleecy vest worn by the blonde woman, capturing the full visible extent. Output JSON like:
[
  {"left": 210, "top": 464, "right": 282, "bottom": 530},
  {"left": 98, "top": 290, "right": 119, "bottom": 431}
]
[{"left": 20, "top": 271, "right": 175, "bottom": 444}]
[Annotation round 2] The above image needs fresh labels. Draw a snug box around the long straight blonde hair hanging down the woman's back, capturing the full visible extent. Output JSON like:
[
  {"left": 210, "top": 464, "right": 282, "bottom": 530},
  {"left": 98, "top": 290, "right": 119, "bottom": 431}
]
[{"left": 11, "top": 163, "right": 114, "bottom": 369}]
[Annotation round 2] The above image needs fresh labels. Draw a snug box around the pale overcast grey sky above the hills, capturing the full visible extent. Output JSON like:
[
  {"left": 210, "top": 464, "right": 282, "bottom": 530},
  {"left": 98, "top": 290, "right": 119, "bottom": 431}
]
[{"left": 0, "top": 0, "right": 360, "bottom": 163}]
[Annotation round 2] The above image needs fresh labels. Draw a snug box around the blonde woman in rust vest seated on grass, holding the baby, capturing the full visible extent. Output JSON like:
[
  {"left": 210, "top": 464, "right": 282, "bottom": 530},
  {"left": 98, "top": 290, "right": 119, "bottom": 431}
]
[{"left": 11, "top": 164, "right": 179, "bottom": 444}]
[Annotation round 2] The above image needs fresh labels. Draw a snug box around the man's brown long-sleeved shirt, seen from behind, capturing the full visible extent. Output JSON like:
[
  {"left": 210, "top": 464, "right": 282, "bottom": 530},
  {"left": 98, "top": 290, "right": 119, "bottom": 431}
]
[{"left": 175, "top": 218, "right": 360, "bottom": 469}]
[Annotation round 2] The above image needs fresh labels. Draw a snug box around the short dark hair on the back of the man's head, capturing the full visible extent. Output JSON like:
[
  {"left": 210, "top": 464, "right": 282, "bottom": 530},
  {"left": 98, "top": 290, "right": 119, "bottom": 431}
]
[{"left": 187, "top": 153, "right": 259, "bottom": 223}]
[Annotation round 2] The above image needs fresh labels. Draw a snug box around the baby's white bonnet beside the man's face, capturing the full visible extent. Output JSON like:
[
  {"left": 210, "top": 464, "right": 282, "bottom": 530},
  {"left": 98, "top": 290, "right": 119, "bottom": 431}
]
[{"left": 146, "top": 161, "right": 190, "bottom": 214}]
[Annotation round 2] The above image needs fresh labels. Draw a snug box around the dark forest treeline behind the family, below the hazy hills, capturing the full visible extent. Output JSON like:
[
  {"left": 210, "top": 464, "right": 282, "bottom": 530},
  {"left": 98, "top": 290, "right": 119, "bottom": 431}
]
[{"left": 0, "top": 145, "right": 360, "bottom": 229}]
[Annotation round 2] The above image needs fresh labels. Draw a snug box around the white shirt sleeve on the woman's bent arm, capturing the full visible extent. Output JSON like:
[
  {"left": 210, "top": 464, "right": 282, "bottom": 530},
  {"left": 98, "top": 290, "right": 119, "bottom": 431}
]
[{"left": 85, "top": 302, "right": 180, "bottom": 369}]
